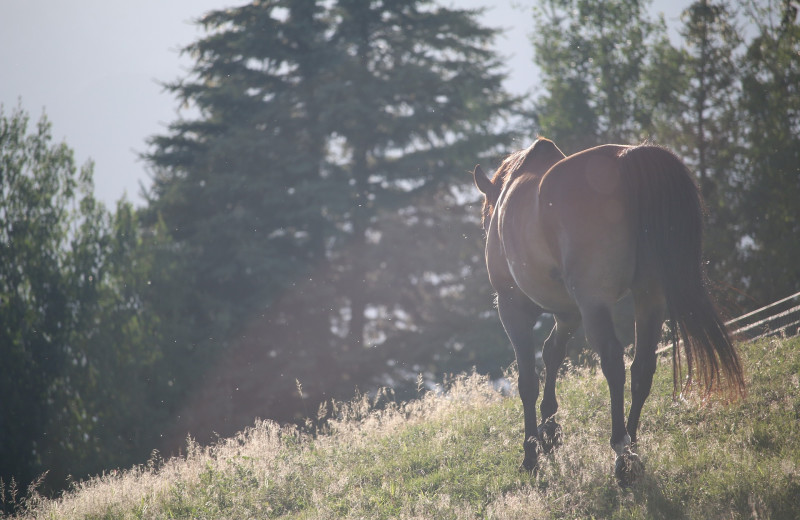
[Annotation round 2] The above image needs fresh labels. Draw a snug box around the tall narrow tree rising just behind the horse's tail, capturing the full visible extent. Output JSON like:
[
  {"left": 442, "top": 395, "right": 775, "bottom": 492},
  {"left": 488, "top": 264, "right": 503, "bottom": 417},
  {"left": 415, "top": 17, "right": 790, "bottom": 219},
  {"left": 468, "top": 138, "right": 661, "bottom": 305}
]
[{"left": 642, "top": 0, "right": 742, "bottom": 300}]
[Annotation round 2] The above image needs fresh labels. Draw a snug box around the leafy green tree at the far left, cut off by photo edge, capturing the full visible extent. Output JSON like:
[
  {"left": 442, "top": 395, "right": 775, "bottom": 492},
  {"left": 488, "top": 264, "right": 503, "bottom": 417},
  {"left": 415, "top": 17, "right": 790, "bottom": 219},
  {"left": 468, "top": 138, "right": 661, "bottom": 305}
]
[{"left": 0, "top": 105, "right": 88, "bottom": 492}]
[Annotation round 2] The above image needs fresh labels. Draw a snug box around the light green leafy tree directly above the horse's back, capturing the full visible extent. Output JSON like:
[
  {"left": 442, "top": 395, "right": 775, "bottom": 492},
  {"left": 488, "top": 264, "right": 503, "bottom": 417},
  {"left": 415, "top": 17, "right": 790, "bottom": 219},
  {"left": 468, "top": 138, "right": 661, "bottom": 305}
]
[{"left": 532, "top": 0, "right": 666, "bottom": 153}]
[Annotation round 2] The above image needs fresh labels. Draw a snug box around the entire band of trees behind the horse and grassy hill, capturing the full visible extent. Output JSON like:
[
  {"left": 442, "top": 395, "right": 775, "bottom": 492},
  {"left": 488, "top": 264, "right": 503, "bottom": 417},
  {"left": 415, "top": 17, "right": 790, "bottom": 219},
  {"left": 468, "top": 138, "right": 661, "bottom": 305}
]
[{"left": 0, "top": 0, "right": 800, "bottom": 504}]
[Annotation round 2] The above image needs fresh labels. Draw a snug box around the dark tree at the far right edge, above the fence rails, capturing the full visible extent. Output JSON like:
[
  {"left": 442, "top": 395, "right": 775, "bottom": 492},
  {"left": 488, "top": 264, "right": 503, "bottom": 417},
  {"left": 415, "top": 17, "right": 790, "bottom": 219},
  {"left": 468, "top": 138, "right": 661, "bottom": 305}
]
[{"left": 737, "top": 0, "right": 800, "bottom": 304}]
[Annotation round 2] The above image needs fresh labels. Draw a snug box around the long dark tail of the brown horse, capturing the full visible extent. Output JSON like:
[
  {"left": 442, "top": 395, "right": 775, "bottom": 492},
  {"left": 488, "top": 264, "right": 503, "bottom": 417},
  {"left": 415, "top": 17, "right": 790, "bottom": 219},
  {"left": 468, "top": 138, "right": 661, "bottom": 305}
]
[{"left": 620, "top": 145, "right": 745, "bottom": 396}]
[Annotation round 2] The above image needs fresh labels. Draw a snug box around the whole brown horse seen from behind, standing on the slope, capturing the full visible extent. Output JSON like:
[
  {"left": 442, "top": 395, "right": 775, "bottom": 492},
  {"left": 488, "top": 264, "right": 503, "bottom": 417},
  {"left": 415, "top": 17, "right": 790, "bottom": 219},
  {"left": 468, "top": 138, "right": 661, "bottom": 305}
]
[{"left": 473, "top": 138, "right": 744, "bottom": 485}]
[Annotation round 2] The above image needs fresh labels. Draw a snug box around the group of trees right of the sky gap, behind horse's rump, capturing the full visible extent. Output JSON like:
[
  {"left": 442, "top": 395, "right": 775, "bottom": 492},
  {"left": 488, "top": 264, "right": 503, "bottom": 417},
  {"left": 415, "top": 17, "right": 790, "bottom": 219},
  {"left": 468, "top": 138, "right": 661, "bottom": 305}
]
[{"left": 533, "top": 0, "right": 800, "bottom": 313}]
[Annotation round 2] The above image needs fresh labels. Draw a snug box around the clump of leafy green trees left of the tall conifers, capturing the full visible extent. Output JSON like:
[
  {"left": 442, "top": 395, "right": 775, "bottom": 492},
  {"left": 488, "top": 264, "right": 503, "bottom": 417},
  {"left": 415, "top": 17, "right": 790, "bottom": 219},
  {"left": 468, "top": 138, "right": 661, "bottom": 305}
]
[{"left": 0, "top": 108, "right": 173, "bottom": 496}]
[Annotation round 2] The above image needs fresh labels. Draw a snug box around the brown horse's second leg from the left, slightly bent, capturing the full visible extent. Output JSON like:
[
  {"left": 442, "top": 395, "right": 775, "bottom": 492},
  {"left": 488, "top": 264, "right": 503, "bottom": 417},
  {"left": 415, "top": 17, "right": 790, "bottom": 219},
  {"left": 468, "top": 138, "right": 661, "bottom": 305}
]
[{"left": 538, "top": 314, "right": 580, "bottom": 453}]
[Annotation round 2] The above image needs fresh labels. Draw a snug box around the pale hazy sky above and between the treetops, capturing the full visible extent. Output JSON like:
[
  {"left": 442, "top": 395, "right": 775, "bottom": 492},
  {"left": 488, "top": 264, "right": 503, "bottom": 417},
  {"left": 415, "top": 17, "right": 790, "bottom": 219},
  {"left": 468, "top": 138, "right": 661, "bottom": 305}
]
[{"left": 0, "top": 0, "right": 689, "bottom": 208}]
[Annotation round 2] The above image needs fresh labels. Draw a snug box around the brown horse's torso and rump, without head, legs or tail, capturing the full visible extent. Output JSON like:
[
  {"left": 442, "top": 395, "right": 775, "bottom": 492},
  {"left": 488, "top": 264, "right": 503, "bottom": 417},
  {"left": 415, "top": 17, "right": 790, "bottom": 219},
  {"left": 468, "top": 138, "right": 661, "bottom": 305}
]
[{"left": 494, "top": 141, "right": 636, "bottom": 313}]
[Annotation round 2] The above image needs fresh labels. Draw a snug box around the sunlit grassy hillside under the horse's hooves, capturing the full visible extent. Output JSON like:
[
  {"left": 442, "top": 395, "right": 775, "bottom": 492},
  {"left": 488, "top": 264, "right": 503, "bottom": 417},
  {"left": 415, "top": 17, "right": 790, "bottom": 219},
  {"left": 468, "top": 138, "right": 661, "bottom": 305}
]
[{"left": 7, "top": 338, "right": 800, "bottom": 519}]
